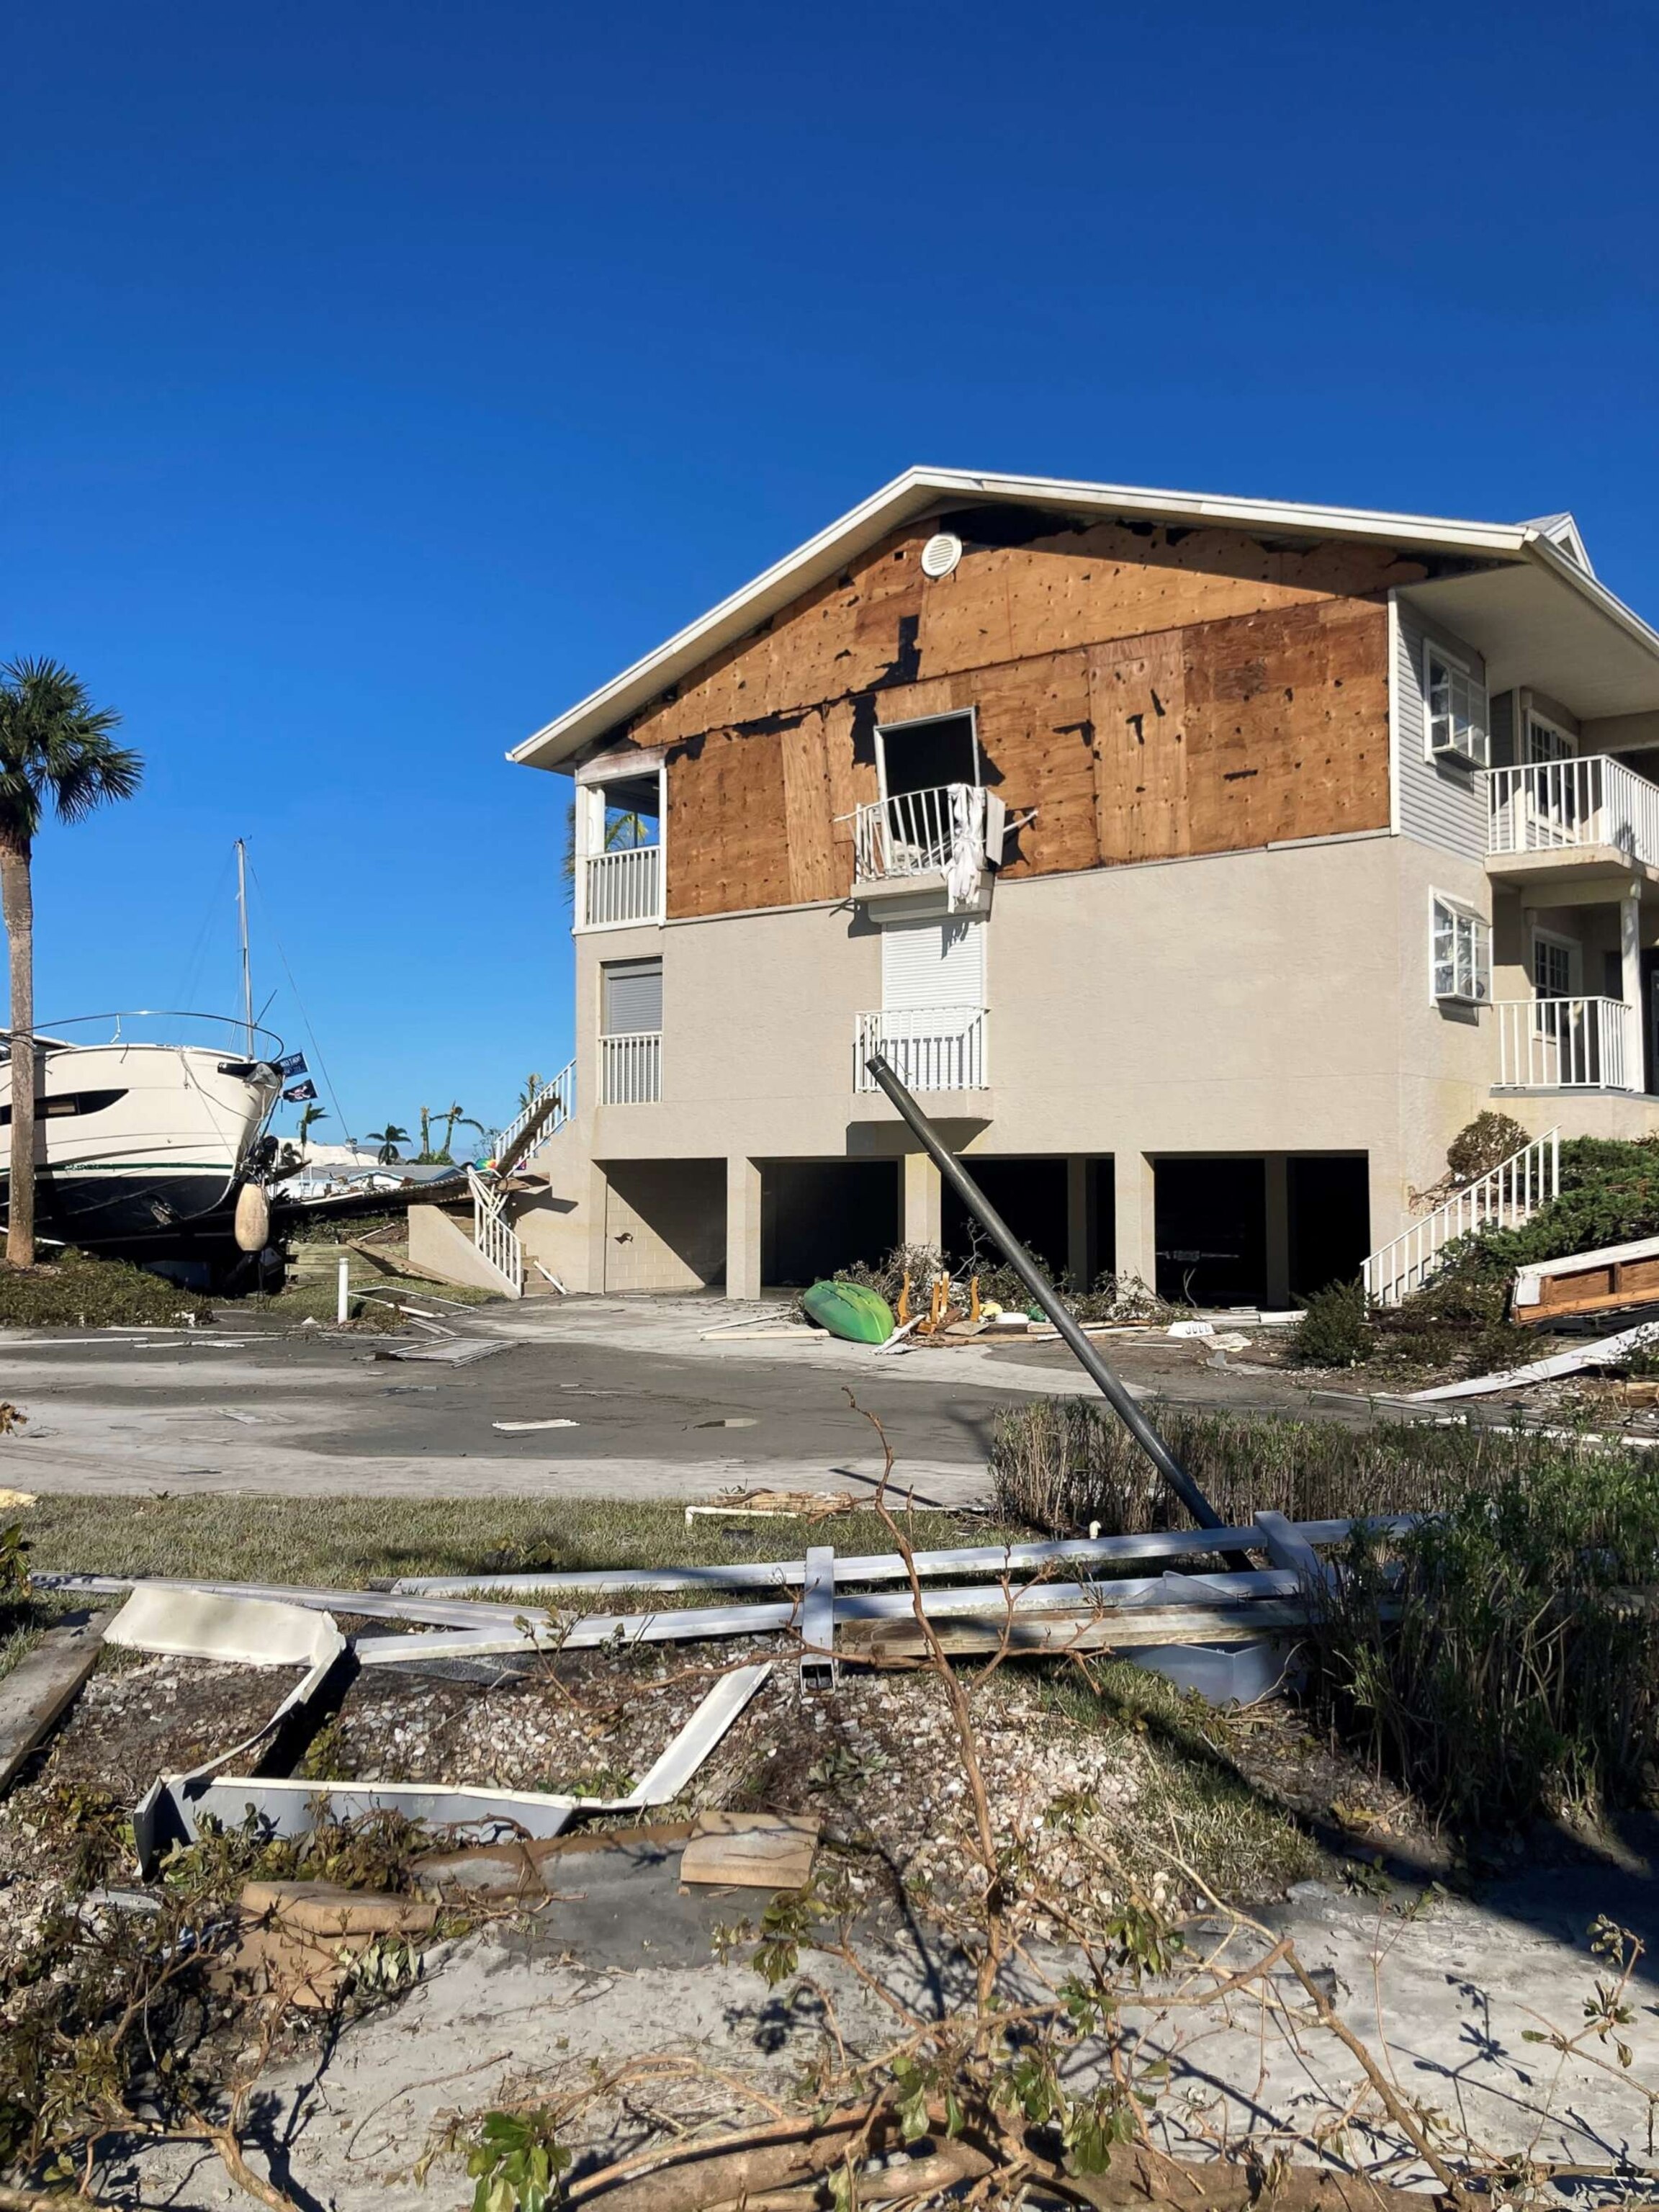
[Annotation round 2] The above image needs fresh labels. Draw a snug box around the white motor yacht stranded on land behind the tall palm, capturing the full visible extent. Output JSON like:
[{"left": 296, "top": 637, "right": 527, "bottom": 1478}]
[{"left": 0, "top": 1013, "right": 292, "bottom": 1248}]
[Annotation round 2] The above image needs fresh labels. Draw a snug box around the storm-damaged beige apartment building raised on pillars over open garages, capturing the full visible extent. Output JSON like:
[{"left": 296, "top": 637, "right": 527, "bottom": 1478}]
[{"left": 449, "top": 469, "right": 1659, "bottom": 1305}]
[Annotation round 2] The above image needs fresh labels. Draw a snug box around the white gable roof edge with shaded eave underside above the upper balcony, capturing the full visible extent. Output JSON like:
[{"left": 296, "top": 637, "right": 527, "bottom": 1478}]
[{"left": 506, "top": 469, "right": 1659, "bottom": 768}]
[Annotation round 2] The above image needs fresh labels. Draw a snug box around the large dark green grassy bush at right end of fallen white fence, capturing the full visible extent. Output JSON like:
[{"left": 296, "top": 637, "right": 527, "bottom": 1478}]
[{"left": 1314, "top": 1447, "right": 1659, "bottom": 1827}]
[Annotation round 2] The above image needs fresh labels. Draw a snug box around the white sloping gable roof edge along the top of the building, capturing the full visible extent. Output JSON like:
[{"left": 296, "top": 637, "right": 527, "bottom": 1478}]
[{"left": 506, "top": 469, "right": 1659, "bottom": 768}]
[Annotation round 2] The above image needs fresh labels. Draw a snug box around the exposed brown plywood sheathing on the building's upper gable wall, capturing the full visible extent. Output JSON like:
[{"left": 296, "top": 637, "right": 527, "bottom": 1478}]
[{"left": 606, "top": 513, "right": 1422, "bottom": 918}]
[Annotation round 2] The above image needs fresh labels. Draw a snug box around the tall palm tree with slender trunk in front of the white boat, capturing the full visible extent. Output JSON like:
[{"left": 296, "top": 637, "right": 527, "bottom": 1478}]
[{"left": 0, "top": 659, "right": 144, "bottom": 1267}]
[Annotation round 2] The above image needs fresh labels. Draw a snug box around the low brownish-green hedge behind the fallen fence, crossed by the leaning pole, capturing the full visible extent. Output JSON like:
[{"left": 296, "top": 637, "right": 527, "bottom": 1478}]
[{"left": 991, "top": 1398, "right": 1557, "bottom": 1535}]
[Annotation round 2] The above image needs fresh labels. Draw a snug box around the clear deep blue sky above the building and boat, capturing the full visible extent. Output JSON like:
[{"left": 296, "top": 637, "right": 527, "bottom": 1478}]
[{"left": 0, "top": 0, "right": 1659, "bottom": 1135}]
